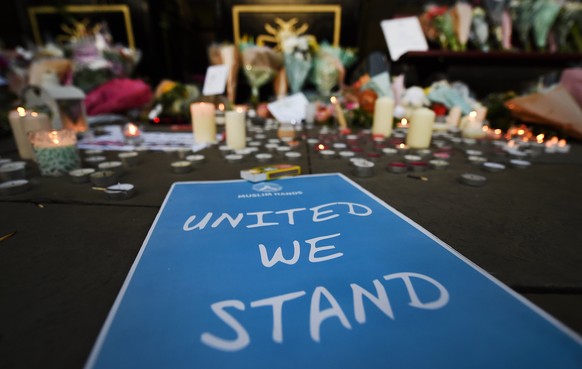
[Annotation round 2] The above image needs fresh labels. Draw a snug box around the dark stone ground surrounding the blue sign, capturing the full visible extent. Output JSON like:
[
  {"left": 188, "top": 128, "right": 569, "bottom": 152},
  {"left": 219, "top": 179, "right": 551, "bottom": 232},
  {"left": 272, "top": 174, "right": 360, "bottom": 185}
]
[{"left": 0, "top": 123, "right": 582, "bottom": 368}]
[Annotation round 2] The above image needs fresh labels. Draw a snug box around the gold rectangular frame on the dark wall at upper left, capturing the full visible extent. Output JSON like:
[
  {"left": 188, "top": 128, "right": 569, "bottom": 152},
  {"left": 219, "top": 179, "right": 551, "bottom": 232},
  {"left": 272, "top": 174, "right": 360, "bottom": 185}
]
[{"left": 28, "top": 5, "right": 135, "bottom": 49}]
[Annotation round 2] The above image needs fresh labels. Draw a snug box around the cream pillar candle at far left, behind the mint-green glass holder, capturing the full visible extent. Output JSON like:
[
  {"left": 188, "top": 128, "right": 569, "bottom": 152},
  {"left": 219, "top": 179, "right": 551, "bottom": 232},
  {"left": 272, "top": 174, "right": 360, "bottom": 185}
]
[{"left": 8, "top": 108, "right": 52, "bottom": 160}]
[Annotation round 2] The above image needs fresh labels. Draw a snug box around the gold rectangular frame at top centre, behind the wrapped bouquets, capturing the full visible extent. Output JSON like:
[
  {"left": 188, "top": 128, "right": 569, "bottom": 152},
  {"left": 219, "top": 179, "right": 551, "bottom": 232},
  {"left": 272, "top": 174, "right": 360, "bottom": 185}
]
[{"left": 232, "top": 5, "right": 342, "bottom": 47}]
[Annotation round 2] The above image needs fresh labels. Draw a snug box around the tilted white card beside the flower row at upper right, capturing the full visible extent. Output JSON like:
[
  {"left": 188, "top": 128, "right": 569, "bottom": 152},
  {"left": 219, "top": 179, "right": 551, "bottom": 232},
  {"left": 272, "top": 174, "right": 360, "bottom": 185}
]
[{"left": 380, "top": 17, "right": 428, "bottom": 61}]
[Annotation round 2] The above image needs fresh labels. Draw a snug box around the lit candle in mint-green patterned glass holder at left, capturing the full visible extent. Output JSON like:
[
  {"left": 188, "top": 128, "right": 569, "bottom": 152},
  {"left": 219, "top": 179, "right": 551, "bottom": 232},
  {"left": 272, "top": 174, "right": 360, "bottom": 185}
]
[{"left": 30, "top": 129, "right": 80, "bottom": 176}]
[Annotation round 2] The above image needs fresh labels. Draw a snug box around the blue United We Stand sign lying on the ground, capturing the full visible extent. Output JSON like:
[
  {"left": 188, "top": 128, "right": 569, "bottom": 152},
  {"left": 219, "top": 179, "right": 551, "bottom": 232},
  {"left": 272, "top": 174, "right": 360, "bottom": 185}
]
[{"left": 86, "top": 174, "right": 582, "bottom": 369}]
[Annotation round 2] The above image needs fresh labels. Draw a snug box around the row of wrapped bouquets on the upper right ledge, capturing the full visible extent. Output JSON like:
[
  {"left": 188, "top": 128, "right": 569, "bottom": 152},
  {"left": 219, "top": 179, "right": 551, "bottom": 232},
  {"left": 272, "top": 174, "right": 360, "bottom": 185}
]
[{"left": 419, "top": 0, "right": 582, "bottom": 52}]
